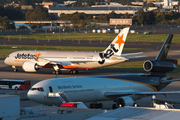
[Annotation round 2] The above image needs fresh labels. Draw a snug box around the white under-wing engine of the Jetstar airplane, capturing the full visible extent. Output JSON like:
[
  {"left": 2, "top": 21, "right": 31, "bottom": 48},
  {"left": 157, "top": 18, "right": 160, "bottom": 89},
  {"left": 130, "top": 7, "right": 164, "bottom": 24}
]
[{"left": 22, "top": 61, "right": 39, "bottom": 72}]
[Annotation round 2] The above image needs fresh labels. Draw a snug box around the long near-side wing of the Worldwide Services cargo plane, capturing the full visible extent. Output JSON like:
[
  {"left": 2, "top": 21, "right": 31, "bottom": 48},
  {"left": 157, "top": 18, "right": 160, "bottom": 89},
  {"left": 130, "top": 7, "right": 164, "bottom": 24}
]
[{"left": 104, "top": 91, "right": 180, "bottom": 97}]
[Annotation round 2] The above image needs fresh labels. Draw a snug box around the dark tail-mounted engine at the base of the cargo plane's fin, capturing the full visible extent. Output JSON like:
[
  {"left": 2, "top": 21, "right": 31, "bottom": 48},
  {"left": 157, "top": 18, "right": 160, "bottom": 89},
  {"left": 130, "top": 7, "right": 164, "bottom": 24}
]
[{"left": 143, "top": 60, "right": 176, "bottom": 73}]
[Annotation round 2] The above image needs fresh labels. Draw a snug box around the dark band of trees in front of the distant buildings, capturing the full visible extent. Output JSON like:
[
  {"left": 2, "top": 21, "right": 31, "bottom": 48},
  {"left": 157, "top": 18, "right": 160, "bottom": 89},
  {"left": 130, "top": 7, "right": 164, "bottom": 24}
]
[{"left": 0, "top": 5, "right": 180, "bottom": 29}]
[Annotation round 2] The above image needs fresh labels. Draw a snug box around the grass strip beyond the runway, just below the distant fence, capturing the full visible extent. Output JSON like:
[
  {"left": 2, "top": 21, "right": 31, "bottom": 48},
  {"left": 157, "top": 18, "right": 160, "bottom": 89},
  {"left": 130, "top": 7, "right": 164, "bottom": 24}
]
[{"left": 0, "top": 33, "right": 180, "bottom": 43}]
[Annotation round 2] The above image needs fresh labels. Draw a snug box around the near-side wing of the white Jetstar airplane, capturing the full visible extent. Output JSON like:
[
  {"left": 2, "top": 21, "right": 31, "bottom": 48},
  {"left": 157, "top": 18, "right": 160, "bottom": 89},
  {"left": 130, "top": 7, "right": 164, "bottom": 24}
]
[{"left": 33, "top": 56, "right": 72, "bottom": 65}]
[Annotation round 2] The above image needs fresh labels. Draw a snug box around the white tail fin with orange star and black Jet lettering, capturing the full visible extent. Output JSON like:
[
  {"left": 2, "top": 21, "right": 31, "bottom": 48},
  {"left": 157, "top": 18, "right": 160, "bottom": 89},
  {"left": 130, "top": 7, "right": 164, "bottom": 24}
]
[{"left": 103, "top": 27, "right": 129, "bottom": 56}]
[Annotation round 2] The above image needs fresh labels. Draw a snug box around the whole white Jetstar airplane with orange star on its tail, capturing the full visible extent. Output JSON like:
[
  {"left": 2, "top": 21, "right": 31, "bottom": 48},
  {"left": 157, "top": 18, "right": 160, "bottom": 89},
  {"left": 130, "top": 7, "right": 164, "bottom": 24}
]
[{"left": 4, "top": 28, "right": 140, "bottom": 74}]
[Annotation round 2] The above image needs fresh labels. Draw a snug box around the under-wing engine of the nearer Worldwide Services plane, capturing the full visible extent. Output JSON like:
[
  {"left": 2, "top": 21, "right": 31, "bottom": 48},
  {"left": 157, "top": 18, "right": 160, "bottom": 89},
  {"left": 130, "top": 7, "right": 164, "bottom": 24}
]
[{"left": 116, "top": 96, "right": 134, "bottom": 107}]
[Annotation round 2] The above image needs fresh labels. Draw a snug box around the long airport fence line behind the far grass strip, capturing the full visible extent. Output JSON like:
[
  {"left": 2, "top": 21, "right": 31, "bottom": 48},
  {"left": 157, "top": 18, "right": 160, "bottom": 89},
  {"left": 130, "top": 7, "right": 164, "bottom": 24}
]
[{"left": 0, "top": 25, "right": 180, "bottom": 35}]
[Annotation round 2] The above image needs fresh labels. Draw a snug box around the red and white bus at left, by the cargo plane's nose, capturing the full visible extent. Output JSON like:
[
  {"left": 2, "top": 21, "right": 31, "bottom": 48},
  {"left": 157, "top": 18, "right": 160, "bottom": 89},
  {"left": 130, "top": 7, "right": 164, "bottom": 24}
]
[{"left": 0, "top": 79, "right": 31, "bottom": 90}]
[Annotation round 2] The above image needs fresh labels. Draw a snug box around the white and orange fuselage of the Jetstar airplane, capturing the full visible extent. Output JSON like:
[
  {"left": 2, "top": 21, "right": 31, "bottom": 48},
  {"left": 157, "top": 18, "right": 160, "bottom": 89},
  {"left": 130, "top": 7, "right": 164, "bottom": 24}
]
[{"left": 4, "top": 51, "right": 126, "bottom": 69}]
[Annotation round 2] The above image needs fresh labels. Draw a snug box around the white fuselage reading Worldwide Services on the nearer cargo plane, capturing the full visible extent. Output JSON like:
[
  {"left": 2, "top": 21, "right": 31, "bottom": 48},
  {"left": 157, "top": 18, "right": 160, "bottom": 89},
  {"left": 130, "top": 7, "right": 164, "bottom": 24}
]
[{"left": 28, "top": 75, "right": 158, "bottom": 105}]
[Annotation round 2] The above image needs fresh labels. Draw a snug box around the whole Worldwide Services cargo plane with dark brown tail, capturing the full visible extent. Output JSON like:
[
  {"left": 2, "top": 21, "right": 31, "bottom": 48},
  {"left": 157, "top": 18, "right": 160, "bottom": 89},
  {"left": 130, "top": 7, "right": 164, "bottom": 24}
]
[{"left": 28, "top": 35, "right": 180, "bottom": 108}]
